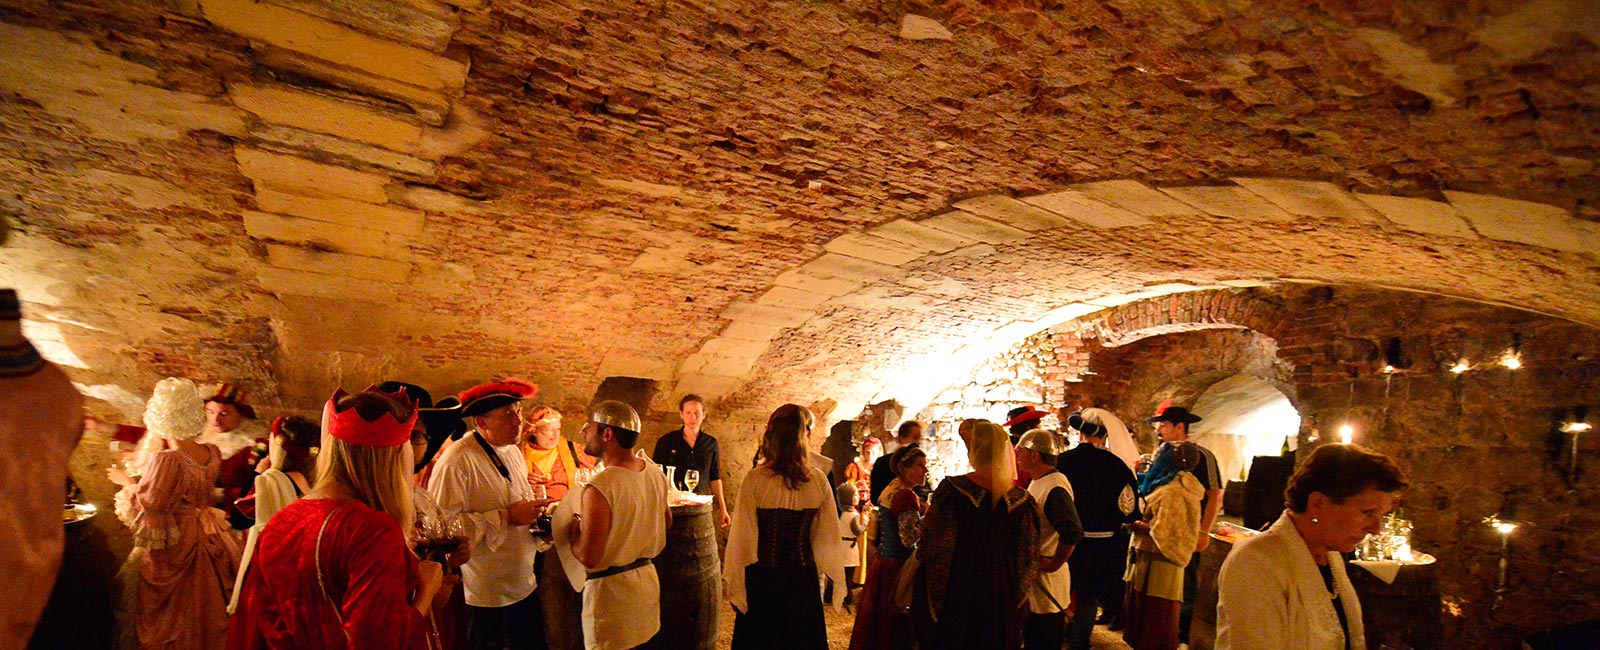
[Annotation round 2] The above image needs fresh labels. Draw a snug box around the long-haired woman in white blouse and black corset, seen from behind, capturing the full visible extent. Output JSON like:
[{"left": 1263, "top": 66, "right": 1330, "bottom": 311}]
[{"left": 723, "top": 403, "right": 845, "bottom": 650}]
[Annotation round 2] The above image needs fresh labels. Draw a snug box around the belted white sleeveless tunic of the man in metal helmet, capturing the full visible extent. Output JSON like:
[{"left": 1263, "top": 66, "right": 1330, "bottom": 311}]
[{"left": 584, "top": 459, "right": 667, "bottom": 650}]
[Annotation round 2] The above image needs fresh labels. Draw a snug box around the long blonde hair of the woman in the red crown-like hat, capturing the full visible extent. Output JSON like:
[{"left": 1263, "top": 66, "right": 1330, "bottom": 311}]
[{"left": 312, "top": 392, "right": 416, "bottom": 532}]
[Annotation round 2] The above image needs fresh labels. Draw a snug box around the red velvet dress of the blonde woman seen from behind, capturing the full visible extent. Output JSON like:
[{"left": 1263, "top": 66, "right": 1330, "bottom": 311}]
[{"left": 227, "top": 498, "right": 430, "bottom": 650}]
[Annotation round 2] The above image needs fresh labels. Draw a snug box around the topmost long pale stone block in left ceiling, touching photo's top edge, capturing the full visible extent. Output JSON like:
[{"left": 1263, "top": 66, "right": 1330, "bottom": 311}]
[{"left": 200, "top": 0, "right": 467, "bottom": 91}]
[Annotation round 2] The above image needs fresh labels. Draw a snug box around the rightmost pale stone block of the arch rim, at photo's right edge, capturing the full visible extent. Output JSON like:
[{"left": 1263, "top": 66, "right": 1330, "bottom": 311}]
[{"left": 1445, "top": 191, "right": 1600, "bottom": 258}]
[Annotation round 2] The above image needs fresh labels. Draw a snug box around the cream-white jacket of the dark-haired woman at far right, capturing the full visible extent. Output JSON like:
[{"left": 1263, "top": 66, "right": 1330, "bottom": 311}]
[{"left": 1216, "top": 511, "right": 1366, "bottom": 650}]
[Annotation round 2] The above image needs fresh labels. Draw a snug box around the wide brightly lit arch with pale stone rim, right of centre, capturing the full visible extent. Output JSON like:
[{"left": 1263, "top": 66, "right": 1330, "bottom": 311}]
[{"left": 694, "top": 178, "right": 1600, "bottom": 411}]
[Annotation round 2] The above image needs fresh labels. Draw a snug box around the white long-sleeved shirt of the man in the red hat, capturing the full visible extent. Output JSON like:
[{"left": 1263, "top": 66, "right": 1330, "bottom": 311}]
[{"left": 429, "top": 434, "right": 536, "bottom": 607}]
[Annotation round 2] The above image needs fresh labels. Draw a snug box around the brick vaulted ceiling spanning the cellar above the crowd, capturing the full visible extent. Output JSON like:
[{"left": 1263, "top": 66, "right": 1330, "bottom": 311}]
[{"left": 0, "top": 0, "right": 1600, "bottom": 419}]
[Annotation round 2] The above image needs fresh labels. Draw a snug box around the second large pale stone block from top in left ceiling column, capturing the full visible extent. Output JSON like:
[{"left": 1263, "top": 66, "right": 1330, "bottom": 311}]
[{"left": 227, "top": 83, "right": 422, "bottom": 154}]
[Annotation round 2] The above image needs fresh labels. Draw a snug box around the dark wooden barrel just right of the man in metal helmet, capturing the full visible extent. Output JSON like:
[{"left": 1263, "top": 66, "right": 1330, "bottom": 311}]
[{"left": 645, "top": 503, "right": 723, "bottom": 650}]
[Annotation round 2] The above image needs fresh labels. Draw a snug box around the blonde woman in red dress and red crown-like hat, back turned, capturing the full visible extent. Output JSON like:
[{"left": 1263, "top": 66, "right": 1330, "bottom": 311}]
[{"left": 229, "top": 389, "right": 443, "bottom": 650}]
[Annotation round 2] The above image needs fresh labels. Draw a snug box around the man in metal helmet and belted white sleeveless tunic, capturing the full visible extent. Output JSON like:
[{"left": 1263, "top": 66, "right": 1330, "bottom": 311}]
[{"left": 568, "top": 400, "right": 672, "bottom": 650}]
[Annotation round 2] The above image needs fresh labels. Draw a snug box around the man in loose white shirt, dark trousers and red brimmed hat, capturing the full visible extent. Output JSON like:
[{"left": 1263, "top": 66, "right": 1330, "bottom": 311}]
[{"left": 430, "top": 379, "right": 547, "bottom": 650}]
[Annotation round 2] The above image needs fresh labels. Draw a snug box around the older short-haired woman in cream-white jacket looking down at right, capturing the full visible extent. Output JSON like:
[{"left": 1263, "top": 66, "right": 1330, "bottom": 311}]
[{"left": 1216, "top": 445, "right": 1406, "bottom": 650}]
